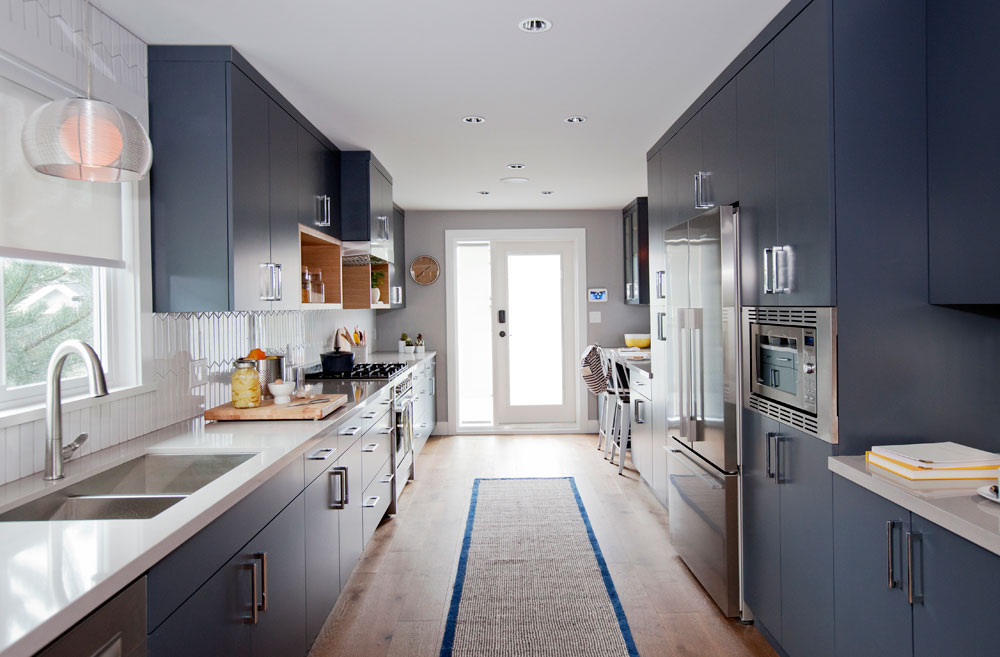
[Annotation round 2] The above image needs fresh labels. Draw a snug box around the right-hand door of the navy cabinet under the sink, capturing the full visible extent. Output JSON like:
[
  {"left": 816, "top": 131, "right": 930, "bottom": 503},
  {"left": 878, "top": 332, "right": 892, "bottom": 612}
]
[{"left": 245, "top": 495, "right": 308, "bottom": 657}]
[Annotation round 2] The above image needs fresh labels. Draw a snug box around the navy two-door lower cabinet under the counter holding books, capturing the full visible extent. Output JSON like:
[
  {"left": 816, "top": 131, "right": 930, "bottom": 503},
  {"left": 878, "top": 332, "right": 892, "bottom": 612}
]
[{"left": 834, "top": 477, "right": 1000, "bottom": 657}]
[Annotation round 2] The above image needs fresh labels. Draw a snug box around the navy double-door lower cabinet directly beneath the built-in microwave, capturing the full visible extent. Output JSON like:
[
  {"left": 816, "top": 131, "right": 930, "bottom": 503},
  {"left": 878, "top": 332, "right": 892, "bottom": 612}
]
[{"left": 743, "top": 411, "right": 834, "bottom": 657}]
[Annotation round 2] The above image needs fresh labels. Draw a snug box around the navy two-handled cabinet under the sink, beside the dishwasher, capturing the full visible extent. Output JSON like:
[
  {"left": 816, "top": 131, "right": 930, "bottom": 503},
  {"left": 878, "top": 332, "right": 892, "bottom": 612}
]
[{"left": 148, "top": 495, "right": 308, "bottom": 657}]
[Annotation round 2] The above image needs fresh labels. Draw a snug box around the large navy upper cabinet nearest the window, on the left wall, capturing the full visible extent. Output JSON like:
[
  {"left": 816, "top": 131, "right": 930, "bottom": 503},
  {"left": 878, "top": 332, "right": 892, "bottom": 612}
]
[{"left": 148, "top": 46, "right": 339, "bottom": 312}]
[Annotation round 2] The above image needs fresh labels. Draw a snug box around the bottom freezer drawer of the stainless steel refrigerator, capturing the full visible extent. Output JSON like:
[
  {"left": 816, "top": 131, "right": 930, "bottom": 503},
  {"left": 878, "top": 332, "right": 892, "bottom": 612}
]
[{"left": 668, "top": 439, "right": 740, "bottom": 616}]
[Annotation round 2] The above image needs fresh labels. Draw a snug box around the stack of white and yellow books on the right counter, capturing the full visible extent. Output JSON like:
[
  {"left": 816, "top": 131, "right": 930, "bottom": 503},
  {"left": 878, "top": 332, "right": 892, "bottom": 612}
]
[{"left": 865, "top": 442, "right": 1000, "bottom": 481}]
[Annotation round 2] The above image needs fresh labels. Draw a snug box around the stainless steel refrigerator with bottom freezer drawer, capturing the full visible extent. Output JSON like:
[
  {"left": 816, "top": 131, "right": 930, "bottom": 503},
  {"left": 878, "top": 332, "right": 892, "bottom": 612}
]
[{"left": 653, "top": 206, "right": 741, "bottom": 616}]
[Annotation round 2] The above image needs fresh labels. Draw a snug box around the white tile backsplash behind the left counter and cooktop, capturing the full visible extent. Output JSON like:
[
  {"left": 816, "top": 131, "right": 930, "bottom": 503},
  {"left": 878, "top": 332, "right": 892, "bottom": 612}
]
[{"left": 0, "top": 306, "right": 375, "bottom": 484}]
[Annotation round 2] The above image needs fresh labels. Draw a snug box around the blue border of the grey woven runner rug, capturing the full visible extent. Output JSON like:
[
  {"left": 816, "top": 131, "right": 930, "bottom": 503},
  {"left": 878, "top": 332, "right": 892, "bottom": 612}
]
[{"left": 441, "top": 477, "right": 639, "bottom": 657}]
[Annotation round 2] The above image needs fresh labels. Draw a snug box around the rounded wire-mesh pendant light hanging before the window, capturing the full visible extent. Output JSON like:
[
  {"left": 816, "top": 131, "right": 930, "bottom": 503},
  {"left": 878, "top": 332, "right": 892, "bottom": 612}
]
[{"left": 21, "top": 0, "right": 153, "bottom": 182}]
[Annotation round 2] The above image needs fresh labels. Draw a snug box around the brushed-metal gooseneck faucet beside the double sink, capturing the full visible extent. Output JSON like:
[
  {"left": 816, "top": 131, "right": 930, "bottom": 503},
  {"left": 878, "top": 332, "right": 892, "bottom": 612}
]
[{"left": 45, "top": 340, "right": 108, "bottom": 481}]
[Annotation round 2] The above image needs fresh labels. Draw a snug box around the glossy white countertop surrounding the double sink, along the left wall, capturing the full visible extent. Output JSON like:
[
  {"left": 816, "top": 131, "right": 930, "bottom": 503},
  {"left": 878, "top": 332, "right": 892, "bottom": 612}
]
[{"left": 0, "top": 352, "right": 435, "bottom": 657}]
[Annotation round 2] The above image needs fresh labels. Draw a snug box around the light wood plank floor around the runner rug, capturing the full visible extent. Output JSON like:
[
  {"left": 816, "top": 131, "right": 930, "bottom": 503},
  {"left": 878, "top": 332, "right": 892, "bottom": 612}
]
[{"left": 310, "top": 435, "right": 775, "bottom": 657}]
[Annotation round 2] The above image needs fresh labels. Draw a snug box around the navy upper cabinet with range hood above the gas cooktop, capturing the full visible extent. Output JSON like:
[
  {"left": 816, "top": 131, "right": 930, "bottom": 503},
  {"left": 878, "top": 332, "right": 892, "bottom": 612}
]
[{"left": 340, "top": 151, "right": 394, "bottom": 262}]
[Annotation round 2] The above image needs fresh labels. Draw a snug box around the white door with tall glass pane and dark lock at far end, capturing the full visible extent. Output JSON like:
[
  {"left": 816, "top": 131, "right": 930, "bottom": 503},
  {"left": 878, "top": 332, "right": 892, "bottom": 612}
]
[{"left": 490, "top": 241, "right": 576, "bottom": 425}]
